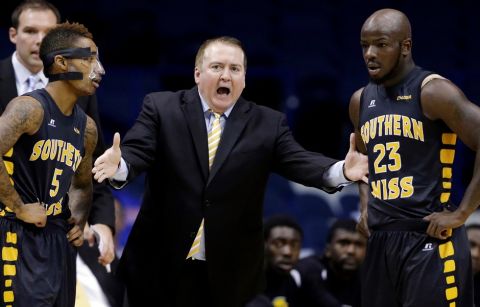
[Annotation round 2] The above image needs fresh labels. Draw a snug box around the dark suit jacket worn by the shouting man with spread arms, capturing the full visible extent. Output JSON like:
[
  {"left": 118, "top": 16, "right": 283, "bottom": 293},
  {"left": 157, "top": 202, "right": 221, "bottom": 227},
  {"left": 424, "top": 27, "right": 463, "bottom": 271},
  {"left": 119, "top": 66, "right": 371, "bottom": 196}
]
[{"left": 119, "top": 87, "right": 336, "bottom": 307}]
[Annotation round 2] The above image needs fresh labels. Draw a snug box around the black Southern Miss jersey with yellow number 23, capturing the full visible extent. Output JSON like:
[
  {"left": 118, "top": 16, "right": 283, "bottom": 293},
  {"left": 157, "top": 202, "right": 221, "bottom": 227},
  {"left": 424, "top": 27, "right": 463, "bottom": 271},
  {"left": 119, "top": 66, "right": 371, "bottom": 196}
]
[{"left": 359, "top": 67, "right": 457, "bottom": 227}]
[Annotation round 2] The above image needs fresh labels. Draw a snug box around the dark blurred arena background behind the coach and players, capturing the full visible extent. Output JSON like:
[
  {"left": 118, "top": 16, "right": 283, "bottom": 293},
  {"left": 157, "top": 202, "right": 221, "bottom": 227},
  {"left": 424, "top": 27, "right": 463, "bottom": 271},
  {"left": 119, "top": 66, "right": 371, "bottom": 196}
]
[{"left": 0, "top": 0, "right": 480, "bottom": 254}]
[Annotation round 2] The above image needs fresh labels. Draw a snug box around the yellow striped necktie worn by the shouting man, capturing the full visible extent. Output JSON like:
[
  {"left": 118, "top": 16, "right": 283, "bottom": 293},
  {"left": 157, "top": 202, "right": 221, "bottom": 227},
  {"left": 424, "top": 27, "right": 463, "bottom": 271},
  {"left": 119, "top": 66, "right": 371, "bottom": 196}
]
[{"left": 187, "top": 112, "right": 222, "bottom": 259}]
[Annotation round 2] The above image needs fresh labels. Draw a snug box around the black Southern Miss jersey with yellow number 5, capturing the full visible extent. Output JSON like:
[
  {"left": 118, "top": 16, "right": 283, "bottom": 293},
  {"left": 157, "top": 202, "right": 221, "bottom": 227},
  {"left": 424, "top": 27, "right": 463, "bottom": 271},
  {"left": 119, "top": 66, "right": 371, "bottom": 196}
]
[{"left": 0, "top": 89, "right": 87, "bottom": 219}]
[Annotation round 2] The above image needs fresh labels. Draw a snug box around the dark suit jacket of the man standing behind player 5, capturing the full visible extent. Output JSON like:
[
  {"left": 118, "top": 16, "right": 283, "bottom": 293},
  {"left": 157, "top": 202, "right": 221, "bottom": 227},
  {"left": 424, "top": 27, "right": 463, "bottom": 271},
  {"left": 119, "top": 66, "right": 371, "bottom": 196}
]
[{"left": 0, "top": 56, "right": 115, "bottom": 230}]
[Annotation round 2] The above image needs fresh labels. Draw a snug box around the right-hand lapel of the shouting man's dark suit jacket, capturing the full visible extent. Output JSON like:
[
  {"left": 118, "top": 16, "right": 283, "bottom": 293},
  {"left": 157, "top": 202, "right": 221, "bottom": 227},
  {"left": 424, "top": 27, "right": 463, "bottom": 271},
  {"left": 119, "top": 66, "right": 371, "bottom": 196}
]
[{"left": 207, "top": 98, "right": 250, "bottom": 185}]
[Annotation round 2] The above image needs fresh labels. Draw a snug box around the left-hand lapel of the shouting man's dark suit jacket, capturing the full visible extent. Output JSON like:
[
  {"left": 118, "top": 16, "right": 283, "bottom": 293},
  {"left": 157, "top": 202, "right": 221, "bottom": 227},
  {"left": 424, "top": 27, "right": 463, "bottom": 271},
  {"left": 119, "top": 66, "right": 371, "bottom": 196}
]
[{"left": 182, "top": 87, "right": 208, "bottom": 179}]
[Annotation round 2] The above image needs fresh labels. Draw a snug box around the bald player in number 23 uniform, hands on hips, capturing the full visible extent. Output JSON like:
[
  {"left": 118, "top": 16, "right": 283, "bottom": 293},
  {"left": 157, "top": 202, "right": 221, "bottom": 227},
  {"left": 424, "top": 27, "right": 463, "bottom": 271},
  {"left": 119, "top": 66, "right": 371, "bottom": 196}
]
[{"left": 350, "top": 9, "right": 480, "bottom": 307}]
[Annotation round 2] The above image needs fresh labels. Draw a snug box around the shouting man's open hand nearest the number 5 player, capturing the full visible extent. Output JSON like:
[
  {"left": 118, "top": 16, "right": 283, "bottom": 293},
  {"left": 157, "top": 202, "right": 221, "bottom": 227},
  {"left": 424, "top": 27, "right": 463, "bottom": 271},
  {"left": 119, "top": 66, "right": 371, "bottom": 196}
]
[{"left": 92, "top": 132, "right": 122, "bottom": 182}]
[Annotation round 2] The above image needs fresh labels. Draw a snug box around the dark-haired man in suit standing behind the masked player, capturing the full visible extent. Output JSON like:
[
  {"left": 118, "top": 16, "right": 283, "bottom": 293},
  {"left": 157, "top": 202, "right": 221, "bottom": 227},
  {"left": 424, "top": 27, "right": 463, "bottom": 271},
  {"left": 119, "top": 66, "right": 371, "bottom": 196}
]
[{"left": 0, "top": 0, "right": 115, "bottom": 265}]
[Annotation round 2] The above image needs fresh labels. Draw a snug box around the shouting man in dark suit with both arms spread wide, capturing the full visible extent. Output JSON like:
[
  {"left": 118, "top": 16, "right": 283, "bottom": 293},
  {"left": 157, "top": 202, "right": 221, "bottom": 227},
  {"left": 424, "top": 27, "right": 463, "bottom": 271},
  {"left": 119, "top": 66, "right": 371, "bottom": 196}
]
[{"left": 93, "top": 37, "right": 367, "bottom": 307}]
